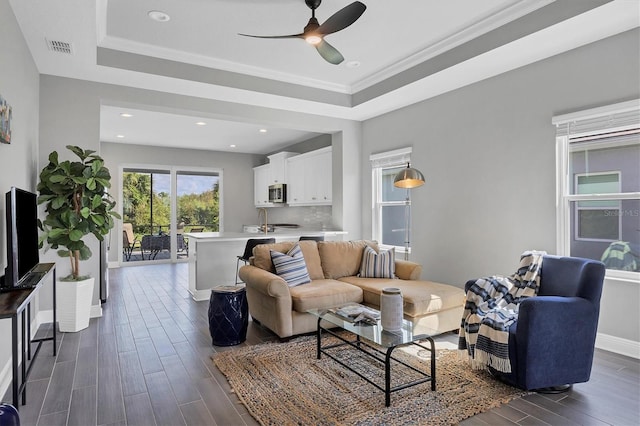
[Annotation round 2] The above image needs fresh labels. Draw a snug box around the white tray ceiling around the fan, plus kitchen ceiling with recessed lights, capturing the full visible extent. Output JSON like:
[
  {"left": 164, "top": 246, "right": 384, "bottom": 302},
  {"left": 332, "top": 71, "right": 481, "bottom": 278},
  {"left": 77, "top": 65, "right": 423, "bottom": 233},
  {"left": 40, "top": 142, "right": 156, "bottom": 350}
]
[{"left": 9, "top": 0, "right": 640, "bottom": 154}]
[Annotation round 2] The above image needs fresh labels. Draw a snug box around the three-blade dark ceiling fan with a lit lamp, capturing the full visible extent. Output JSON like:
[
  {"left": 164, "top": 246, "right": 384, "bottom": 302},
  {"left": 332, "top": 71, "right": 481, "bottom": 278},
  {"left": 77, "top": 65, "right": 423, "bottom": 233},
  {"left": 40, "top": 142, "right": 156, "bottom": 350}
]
[{"left": 240, "top": 0, "right": 367, "bottom": 65}]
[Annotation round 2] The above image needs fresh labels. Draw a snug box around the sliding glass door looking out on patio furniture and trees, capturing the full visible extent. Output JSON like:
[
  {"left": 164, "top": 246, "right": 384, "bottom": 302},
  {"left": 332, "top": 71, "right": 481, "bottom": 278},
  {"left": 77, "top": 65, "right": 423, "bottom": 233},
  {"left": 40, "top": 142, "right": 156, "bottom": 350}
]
[{"left": 122, "top": 168, "right": 220, "bottom": 262}]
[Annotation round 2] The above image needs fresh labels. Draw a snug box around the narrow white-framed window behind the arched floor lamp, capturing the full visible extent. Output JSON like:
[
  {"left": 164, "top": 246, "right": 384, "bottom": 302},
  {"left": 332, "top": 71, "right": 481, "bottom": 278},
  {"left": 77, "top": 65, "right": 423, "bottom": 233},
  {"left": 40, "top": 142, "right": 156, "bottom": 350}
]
[{"left": 370, "top": 148, "right": 411, "bottom": 253}]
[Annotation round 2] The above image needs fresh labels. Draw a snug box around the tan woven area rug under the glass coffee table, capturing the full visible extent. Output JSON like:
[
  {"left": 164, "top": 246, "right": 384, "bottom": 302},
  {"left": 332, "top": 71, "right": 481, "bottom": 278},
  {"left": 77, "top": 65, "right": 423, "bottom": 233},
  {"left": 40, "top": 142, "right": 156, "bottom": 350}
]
[{"left": 212, "top": 336, "right": 527, "bottom": 425}]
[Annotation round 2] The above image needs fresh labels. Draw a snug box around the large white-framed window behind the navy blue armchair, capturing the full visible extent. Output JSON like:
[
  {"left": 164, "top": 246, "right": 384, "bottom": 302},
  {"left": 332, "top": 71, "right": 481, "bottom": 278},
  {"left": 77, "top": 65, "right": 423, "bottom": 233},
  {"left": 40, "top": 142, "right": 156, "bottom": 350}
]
[{"left": 553, "top": 100, "right": 640, "bottom": 280}]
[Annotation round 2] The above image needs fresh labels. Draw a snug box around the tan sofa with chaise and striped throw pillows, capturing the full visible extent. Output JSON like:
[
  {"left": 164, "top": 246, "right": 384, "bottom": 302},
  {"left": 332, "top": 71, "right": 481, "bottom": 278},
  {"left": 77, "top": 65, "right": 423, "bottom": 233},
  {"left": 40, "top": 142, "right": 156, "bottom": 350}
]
[{"left": 240, "top": 240, "right": 465, "bottom": 338}]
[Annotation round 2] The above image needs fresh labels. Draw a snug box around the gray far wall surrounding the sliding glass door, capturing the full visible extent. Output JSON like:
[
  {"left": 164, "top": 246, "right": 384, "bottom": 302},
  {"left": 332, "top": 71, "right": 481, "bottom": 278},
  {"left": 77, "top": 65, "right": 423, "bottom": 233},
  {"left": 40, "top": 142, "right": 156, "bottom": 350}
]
[{"left": 100, "top": 142, "right": 262, "bottom": 262}]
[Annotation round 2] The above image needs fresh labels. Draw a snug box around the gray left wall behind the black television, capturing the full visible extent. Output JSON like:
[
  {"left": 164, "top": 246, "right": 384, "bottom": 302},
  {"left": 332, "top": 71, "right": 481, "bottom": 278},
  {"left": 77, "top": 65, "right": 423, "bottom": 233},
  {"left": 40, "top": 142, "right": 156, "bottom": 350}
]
[{"left": 0, "top": 0, "right": 40, "bottom": 395}]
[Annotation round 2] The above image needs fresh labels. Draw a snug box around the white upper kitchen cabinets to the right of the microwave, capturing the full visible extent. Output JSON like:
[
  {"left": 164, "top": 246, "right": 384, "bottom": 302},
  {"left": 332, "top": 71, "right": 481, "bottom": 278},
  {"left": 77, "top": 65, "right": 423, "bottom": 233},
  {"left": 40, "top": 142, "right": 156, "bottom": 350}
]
[{"left": 287, "top": 147, "right": 333, "bottom": 206}]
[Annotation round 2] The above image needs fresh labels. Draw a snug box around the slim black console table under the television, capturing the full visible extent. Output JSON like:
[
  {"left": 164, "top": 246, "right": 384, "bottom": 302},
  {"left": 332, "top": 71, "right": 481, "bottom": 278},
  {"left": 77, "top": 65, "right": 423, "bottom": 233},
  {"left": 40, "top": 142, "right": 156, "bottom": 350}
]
[{"left": 0, "top": 263, "right": 57, "bottom": 409}]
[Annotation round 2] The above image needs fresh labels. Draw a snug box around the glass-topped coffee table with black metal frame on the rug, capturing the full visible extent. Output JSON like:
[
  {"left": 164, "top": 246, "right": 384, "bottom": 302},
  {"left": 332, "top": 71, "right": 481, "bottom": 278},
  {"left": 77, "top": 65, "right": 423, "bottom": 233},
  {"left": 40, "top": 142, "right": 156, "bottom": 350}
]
[{"left": 307, "top": 303, "right": 442, "bottom": 407}]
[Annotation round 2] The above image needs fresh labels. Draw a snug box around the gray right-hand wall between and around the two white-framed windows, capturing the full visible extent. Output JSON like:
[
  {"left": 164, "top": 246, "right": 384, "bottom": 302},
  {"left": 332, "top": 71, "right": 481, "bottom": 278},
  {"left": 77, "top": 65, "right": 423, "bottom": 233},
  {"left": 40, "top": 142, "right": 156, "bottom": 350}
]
[{"left": 361, "top": 29, "right": 640, "bottom": 342}]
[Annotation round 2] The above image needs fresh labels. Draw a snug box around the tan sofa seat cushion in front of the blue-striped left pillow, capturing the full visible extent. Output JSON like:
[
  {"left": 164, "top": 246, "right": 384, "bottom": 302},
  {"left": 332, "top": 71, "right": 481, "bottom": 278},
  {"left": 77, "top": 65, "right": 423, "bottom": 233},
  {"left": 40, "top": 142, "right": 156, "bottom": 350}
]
[{"left": 289, "top": 279, "right": 362, "bottom": 312}]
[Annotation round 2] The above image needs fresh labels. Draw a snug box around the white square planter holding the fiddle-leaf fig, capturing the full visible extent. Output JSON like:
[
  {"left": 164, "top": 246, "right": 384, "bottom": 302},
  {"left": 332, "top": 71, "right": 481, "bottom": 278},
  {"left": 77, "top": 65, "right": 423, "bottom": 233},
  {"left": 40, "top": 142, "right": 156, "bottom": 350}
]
[{"left": 56, "top": 278, "right": 95, "bottom": 333}]
